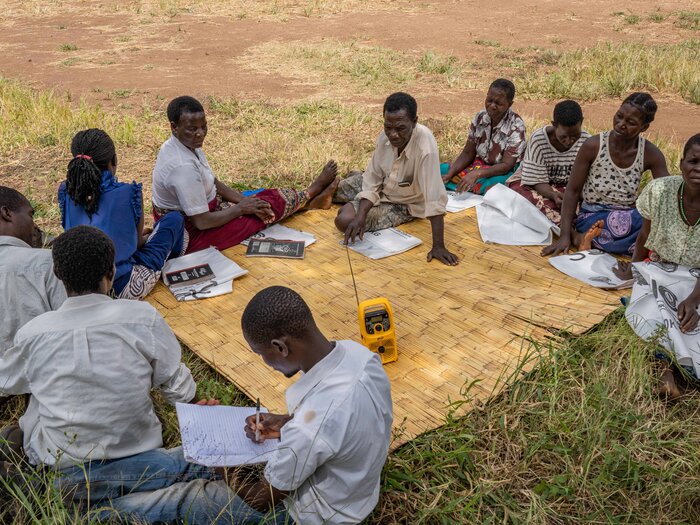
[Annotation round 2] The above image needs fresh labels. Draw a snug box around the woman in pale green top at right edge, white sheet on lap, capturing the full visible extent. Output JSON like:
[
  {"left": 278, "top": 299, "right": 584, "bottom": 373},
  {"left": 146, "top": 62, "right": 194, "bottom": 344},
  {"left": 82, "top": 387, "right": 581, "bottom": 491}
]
[{"left": 621, "top": 134, "right": 700, "bottom": 399}]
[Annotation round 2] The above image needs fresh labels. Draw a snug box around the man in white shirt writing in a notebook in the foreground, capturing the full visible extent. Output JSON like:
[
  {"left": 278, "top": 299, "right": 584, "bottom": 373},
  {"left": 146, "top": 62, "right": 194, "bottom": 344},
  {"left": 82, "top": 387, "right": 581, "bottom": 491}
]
[{"left": 97, "top": 286, "right": 393, "bottom": 525}]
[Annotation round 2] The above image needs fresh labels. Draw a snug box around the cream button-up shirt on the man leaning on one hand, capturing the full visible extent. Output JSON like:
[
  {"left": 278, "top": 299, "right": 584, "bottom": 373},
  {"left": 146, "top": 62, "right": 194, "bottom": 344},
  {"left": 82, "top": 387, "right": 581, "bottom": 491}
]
[{"left": 357, "top": 124, "right": 447, "bottom": 218}]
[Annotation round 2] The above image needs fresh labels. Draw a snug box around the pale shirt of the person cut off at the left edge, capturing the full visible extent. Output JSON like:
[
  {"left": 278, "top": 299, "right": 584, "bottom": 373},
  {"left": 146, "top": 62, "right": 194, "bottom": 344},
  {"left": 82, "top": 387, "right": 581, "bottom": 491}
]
[{"left": 0, "top": 235, "right": 66, "bottom": 352}]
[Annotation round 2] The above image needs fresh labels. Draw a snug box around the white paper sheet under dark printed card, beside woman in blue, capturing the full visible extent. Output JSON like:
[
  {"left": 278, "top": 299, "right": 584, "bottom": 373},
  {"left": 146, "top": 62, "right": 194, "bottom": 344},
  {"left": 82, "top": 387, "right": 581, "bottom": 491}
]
[{"left": 162, "top": 246, "right": 248, "bottom": 301}]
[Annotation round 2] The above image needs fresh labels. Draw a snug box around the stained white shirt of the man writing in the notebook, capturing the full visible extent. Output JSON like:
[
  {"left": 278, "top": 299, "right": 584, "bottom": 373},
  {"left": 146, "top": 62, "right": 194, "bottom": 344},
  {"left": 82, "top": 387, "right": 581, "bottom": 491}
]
[{"left": 265, "top": 341, "right": 393, "bottom": 525}]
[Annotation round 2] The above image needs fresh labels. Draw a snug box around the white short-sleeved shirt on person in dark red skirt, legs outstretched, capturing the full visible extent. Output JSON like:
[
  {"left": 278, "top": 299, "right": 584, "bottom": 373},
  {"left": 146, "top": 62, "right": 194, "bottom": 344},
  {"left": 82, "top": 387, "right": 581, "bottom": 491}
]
[{"left": 152, "top": 135, "right": 216, "bottom": 216}]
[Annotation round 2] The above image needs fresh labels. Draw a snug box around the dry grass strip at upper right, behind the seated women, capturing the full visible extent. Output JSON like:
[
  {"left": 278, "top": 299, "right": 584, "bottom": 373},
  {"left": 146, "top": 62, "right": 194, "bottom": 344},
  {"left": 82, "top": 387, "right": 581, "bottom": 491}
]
[{"left": 516, "top": 40, "right": 700, "bottom": 104}]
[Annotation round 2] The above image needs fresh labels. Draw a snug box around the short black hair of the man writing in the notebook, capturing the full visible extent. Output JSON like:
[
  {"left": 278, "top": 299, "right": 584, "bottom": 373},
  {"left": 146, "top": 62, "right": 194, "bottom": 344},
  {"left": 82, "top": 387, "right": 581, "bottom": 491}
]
[{"left": 241, "top": 286, "right": 316, "bottom": 344}]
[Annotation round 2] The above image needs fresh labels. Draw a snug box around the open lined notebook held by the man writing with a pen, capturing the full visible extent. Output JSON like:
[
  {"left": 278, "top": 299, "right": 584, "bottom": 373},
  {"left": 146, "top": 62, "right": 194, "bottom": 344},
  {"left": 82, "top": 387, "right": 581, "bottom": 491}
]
[{"left": 175, "top": 403, "right": 279, "bottom": 467}]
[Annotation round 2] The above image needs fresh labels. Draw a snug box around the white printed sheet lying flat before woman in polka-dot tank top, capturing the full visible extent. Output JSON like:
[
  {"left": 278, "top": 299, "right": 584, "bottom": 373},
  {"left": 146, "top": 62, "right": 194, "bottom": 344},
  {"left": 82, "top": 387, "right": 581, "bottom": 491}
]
[{"left": 549, "top": 250, "right": 634, "bottom": 290}]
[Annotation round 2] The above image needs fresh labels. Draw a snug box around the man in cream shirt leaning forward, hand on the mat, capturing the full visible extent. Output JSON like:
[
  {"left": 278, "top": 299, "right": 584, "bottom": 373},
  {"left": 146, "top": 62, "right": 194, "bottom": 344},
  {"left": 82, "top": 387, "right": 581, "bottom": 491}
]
[{"left": 333, "top": 93, "right": 458, "bottom": 266}]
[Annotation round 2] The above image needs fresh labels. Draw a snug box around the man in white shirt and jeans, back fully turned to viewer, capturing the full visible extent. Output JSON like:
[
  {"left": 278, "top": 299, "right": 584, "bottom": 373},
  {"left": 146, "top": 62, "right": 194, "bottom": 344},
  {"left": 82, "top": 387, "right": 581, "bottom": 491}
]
[{"left": 0, "top": 226, "right": 214, "bottom": 508}]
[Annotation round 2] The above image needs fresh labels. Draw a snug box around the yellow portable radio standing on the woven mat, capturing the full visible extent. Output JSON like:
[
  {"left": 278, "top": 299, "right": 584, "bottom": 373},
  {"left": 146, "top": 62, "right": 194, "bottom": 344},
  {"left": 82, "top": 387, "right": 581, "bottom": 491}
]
[{"left": 357, "top": 297, "right": 399, "bottom": 364}]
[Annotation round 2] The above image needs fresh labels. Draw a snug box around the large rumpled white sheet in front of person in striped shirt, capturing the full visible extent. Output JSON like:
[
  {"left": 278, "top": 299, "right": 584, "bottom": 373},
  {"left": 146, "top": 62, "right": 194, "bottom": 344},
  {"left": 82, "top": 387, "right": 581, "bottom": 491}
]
[{"left": 476, "top": 184, "right": 559, "bottom": 246}]
